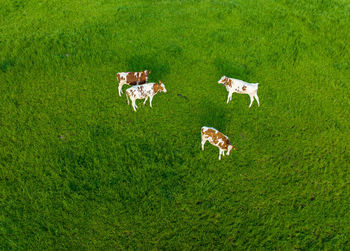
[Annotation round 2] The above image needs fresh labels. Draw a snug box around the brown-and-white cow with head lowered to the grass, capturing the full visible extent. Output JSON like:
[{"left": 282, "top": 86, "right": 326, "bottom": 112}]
[{"left": 201, "top": 126, "right": 237, "bottom": 160}]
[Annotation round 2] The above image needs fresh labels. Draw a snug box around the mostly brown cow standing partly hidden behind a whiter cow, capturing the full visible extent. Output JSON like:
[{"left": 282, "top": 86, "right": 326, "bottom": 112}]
[{"left": 117, "top": 70, "right": 152, "bottom": 96}]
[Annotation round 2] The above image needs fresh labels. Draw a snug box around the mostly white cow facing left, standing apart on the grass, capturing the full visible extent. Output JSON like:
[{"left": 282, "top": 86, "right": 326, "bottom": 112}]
[{"left": 218, "top": 76, "right": 260, "bottom": 108}]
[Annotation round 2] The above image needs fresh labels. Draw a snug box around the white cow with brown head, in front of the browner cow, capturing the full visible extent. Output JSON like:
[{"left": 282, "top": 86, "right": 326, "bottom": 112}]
[{"left": 125, "top": 80, "right": 166, "bottom": 112}]
